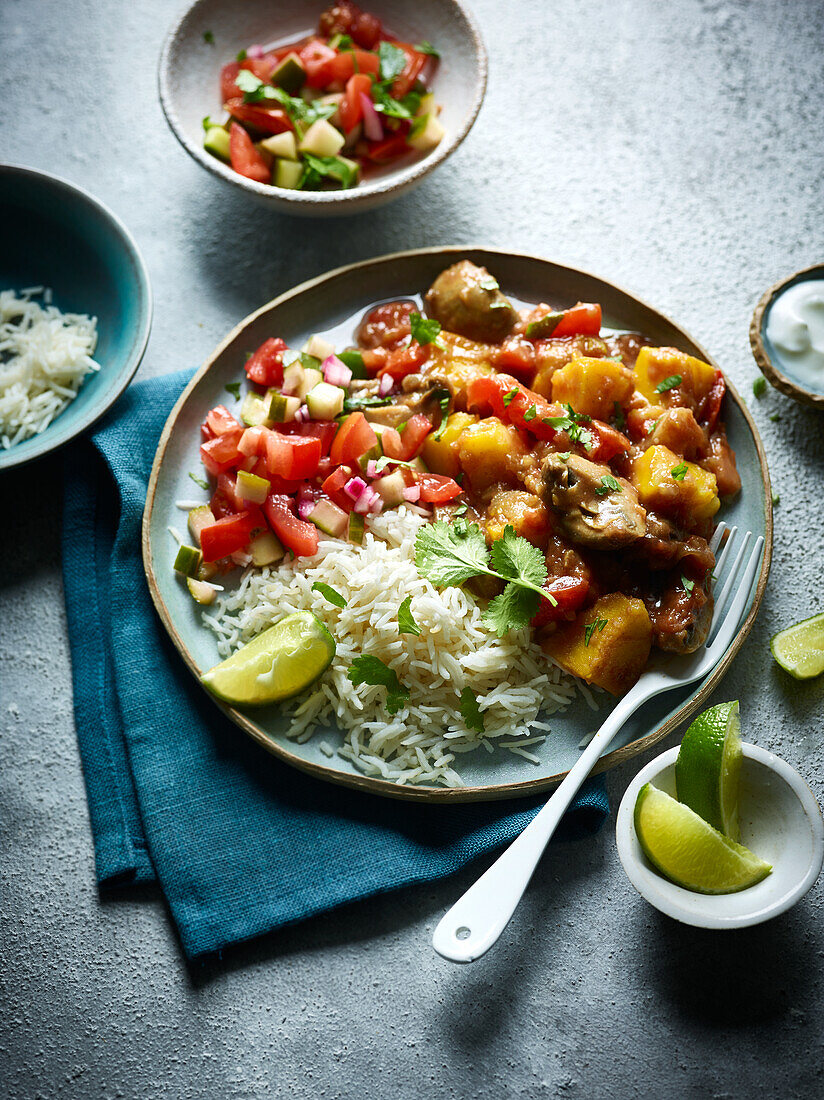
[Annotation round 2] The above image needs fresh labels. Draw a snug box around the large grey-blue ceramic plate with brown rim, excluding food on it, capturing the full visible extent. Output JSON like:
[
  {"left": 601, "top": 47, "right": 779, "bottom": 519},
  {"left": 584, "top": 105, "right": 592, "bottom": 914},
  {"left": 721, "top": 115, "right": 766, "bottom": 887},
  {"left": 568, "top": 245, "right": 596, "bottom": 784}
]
[{"left": 143, "top": 248, "right": 772, "bottom": 802}]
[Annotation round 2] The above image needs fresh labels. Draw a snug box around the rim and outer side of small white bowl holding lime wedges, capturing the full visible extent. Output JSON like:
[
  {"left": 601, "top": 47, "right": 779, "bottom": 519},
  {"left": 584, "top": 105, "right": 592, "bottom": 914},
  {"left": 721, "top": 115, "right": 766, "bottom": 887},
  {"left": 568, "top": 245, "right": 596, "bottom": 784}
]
[{"left": 615, "top": 741, "right": 824, "bottom": 931}]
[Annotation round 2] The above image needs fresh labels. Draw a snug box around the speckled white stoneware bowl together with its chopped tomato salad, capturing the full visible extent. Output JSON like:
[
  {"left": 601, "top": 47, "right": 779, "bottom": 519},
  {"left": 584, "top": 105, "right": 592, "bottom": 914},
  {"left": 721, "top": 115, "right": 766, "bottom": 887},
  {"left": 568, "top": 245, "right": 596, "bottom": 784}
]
[{"left": 158, "top": 0, "right": 486, "bottom": 216}]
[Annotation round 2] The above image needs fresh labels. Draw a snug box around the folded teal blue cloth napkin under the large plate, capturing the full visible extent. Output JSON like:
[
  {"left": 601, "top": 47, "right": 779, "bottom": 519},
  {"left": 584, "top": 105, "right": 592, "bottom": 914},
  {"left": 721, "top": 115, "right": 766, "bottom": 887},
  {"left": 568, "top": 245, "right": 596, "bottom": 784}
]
[{"left": 63, "top": 372, "right": 608, "bottom": 956}]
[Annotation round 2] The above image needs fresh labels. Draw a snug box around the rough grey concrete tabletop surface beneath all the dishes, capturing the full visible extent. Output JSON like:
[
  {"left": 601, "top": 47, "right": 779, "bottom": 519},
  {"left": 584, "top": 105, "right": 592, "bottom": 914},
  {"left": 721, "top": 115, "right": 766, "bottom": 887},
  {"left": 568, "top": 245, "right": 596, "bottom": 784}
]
[{"left": 0, "top": 0, "right": 824, "bottom": 1100}]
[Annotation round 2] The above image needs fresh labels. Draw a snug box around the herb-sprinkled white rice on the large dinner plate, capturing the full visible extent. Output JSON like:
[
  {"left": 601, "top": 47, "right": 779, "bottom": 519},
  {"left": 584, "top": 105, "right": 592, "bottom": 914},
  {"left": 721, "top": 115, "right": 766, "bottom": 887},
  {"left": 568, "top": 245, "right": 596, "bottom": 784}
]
[{"left": 204, "top": 506, "right": 578, "bottom": 787}]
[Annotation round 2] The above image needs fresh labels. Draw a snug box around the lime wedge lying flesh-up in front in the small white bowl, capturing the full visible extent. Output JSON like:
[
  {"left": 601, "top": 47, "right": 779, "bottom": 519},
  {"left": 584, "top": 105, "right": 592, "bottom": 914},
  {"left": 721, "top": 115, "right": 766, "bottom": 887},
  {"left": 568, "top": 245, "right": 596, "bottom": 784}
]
[{"left": 635, "top": 783, "right": 772, "bottom": 894}]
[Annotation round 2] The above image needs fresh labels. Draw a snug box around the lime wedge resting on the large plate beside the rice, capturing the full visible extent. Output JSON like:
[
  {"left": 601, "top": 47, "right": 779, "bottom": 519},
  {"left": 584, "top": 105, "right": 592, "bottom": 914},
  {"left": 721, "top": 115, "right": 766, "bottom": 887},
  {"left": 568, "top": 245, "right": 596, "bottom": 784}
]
[{"left": 200, "top": 612, "right": 334, "bottom": 706}]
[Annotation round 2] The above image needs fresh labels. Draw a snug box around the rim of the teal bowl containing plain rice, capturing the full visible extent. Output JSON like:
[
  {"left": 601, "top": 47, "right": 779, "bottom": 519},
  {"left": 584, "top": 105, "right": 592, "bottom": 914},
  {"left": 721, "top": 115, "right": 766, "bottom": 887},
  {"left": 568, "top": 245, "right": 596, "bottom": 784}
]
[{"left": 0, "top": 164, "right": 153, "bottom": 471}]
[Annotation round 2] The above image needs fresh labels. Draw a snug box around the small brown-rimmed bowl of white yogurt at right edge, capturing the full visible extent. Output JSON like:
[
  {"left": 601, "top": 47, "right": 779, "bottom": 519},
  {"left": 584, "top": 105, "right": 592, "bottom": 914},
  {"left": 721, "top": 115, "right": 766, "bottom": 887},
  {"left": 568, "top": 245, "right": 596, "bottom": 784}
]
[{"left": 749, "top": 264, "right": 824, "bottom": 409}]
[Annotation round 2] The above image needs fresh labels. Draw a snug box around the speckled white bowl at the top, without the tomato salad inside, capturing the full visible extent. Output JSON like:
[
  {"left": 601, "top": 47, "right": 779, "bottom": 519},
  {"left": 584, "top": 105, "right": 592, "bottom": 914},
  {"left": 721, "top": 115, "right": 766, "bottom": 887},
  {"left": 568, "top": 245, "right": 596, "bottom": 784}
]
[{"left": 158, "top": 0, "right": 486, "bottom": 217}]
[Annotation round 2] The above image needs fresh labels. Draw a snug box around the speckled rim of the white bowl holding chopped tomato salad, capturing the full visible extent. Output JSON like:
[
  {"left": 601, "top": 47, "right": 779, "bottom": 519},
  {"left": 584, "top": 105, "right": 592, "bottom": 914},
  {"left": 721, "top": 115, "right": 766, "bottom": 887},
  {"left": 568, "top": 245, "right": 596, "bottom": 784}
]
[{"left": 157, "top": 0, "right": 488, "bottom": 215}]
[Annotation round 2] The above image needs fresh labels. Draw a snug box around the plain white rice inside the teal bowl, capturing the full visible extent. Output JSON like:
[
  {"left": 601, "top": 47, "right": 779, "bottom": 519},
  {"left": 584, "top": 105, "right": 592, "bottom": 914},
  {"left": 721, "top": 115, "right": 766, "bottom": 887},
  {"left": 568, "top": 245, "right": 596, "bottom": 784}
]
[{"left": 0, "top": 286, "right": 100, "bottom": 449}]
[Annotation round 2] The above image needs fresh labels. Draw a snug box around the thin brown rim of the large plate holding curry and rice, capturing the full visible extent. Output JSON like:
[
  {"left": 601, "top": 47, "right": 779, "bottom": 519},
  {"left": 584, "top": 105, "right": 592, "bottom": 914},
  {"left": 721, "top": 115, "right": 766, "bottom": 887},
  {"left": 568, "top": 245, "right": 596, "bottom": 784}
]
[{"left": 141, "top": 244, "right": 772, "bottom": 805}]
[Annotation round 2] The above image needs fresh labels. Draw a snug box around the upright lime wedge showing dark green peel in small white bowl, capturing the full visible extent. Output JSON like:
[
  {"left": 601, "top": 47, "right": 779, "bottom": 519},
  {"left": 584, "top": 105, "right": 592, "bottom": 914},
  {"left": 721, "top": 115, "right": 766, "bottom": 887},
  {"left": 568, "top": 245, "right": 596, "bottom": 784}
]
[{"left": 675, "top": 701, "right": 741, "bottom": 840}]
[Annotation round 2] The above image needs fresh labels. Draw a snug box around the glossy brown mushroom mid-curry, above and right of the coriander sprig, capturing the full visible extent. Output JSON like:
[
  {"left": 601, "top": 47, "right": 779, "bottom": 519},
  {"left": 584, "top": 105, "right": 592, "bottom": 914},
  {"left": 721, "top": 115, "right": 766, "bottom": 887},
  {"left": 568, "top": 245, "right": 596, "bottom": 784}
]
[{"left": 543, "top": 453, "right": 647, "bottom": 550}]
